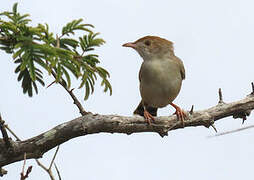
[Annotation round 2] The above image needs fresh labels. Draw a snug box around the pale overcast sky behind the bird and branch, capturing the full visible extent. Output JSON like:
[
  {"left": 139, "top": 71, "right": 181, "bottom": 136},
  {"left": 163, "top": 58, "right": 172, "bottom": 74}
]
[{"left": 0, "top": 0, "right": 254, "bottom": 180}]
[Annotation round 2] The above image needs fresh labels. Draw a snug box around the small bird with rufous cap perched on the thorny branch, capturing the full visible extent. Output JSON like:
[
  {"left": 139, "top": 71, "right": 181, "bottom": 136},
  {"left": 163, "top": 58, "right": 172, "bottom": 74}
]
[{"left": 123, "top": 36, "right": 186, "bottom": 125}]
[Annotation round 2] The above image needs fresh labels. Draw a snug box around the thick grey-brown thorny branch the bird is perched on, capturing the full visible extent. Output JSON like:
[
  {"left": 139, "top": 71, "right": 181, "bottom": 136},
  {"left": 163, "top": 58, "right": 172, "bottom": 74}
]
[{"left": 0, "top": 95, "right": 254, "bottom": 167}]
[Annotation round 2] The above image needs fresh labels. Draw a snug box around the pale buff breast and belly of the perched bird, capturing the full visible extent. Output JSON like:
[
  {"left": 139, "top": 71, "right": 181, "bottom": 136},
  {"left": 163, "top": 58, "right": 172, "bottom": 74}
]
[{"left": 140, "top": 60, "right": 182, "bottom": 107}]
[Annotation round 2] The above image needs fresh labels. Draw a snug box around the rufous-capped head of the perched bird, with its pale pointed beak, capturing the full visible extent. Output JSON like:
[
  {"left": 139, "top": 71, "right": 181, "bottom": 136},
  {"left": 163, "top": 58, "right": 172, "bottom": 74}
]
[{"left": 123, "top": 36, "right": 174, "bottom": 61}]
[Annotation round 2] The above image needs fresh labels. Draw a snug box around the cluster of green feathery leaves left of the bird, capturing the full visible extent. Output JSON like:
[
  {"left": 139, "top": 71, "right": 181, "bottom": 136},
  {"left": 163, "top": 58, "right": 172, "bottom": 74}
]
[{"left": 0, "top": 3, "right": 112, "bottom": 99}]
